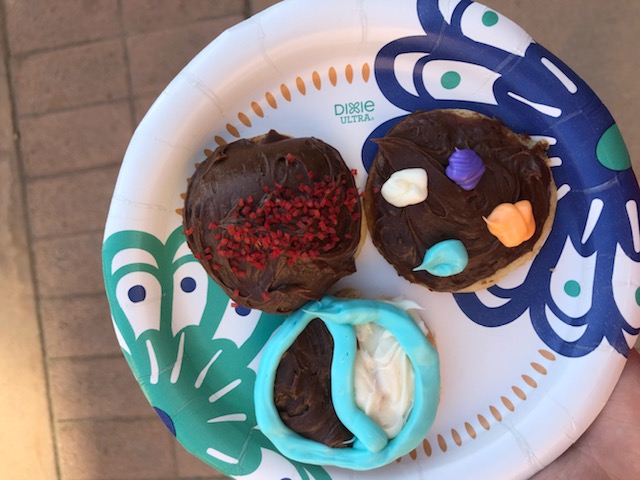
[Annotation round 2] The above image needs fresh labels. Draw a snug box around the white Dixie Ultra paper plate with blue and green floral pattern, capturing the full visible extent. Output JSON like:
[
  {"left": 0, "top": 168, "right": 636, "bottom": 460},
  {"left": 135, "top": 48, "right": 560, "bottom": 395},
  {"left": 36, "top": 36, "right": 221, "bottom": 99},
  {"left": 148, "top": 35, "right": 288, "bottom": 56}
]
[{"left": 103, "top": 0, "right": 640, "bottom": 480}]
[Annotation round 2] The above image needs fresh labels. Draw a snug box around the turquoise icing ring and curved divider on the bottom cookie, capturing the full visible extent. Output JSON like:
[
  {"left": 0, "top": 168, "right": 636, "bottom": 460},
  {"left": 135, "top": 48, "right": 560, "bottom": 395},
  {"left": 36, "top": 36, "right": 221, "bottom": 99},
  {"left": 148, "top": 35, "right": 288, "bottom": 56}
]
[{"left": 254, "top": 297, "right": 440, "bottom": 470}]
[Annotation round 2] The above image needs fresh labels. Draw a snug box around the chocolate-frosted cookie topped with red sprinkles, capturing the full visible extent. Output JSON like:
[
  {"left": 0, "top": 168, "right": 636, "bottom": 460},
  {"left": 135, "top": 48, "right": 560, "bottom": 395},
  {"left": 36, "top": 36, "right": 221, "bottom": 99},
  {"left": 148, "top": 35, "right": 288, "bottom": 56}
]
[{"left": 183, "top": 130, "right": 361, "bottom": 313}]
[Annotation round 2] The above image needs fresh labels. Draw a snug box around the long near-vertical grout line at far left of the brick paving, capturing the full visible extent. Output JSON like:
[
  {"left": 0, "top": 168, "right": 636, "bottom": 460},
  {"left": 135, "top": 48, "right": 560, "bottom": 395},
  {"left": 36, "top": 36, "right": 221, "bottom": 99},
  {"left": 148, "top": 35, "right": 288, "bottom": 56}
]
[{"left": 0, "top": 2, "right": 61, "bottom": 479}]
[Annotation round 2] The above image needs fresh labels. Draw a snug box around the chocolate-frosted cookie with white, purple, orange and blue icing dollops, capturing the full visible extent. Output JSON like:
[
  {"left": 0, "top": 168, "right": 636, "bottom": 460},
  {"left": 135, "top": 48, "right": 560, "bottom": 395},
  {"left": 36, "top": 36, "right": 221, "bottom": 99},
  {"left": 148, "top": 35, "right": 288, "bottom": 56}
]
[{"left": 364, "top": 110, "right": 556, "bottom": 292}]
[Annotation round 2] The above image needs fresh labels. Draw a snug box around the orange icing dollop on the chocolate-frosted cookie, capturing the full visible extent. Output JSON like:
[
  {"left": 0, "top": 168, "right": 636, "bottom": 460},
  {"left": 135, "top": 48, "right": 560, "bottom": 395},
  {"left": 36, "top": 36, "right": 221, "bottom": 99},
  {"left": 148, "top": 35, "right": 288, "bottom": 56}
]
[{"left": 483, "top": 200, "right": 536, "bottom": 248}]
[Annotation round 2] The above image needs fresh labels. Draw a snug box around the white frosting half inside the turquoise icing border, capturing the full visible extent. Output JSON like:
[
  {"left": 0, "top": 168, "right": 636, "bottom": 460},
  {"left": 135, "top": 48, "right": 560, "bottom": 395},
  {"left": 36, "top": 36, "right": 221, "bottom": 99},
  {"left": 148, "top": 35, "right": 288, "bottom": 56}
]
[{"left": 354, "top": 322, "right": 420, "bottom": 438}]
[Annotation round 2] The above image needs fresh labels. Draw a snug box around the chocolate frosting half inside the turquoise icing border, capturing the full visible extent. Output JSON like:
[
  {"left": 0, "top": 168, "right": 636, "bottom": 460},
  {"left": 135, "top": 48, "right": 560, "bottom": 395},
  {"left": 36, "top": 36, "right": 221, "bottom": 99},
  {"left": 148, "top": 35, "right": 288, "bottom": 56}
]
[{"left": 274, "top": 318, "right": 353, "bottom": 447}]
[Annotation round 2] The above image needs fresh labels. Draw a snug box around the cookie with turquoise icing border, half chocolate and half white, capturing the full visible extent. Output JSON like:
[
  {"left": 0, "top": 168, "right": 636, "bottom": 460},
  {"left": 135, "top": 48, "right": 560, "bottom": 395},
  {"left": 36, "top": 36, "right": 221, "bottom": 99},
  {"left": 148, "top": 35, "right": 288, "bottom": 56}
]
[{"left": 254, "top": 297, "right": 440, "bottom": 470}]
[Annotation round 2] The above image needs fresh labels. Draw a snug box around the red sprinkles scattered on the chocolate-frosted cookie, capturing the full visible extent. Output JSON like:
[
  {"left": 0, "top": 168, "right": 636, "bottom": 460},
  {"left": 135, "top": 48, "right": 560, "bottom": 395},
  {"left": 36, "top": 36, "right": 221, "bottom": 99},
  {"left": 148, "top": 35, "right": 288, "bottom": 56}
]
[{"left": 204, "top": 176, "right": 360, "bottom": 276}]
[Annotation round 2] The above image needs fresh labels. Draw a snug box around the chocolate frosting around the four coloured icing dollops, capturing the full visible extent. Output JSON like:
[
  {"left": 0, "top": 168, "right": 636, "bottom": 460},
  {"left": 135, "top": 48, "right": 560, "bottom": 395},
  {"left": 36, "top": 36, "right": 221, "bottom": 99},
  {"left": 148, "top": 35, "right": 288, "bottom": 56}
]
[{"left": 364, "top": 110, "right": 553, "bottom": 291}]
